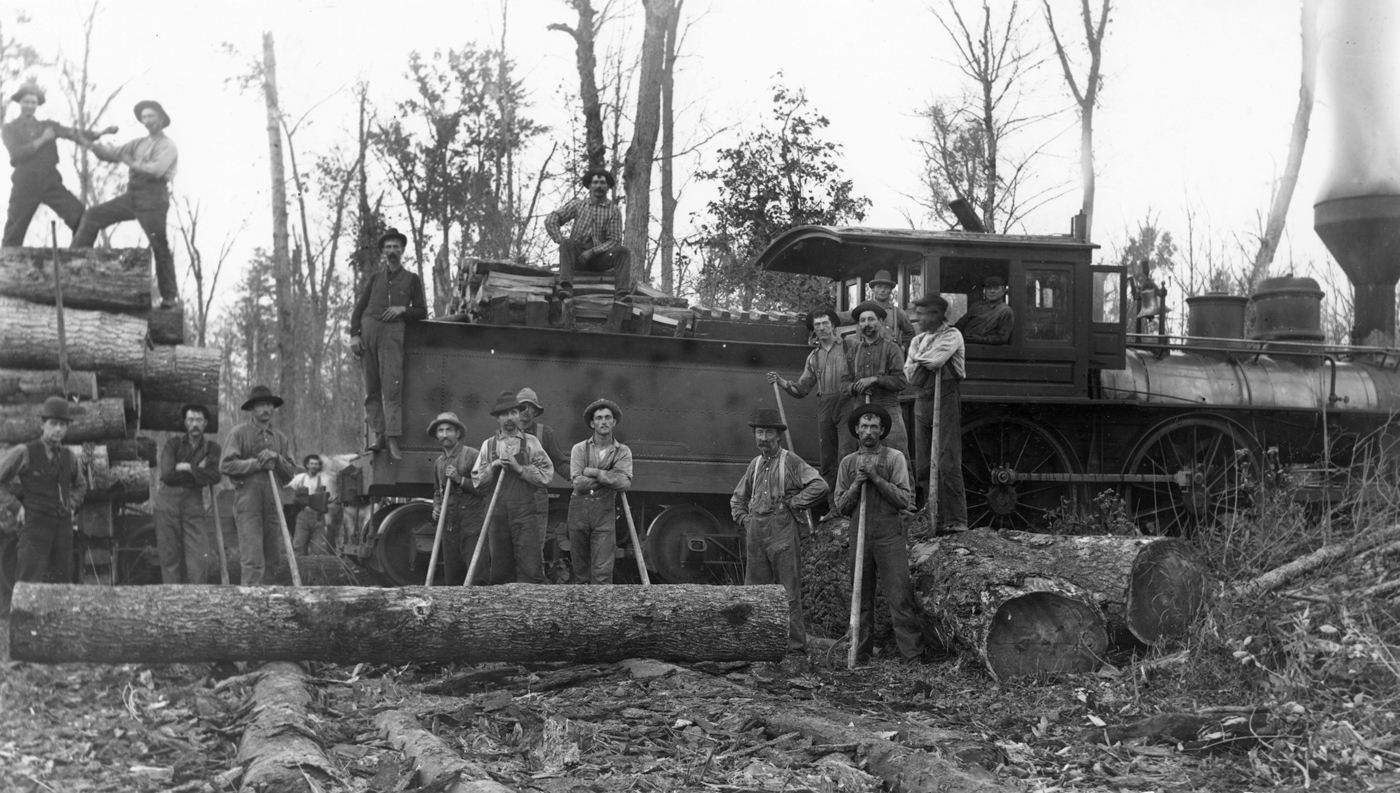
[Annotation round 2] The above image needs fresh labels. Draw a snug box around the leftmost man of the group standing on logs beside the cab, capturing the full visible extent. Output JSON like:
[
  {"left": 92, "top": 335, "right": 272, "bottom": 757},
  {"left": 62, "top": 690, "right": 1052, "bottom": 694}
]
[{"left": 769, "top": 308, "right": 860, "bottom": 514}]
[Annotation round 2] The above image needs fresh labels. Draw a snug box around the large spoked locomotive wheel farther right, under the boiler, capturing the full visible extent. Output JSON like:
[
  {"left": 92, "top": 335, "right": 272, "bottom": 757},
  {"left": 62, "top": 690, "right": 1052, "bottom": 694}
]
[{"left": 1123, "top": 416, "right": 1261, "bottom": 535}]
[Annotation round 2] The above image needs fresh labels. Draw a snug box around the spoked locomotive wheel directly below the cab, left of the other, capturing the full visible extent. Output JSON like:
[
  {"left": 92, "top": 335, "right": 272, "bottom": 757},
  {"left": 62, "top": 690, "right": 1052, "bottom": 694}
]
[{"left": 962, "top": 416, "right": 1078, "bottom": 530}]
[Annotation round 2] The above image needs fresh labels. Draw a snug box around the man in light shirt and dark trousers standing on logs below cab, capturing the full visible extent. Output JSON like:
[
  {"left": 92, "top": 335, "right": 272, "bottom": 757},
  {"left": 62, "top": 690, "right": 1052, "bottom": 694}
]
[{"left": 904, "top": 294, "right": 967, "bottom": 531}]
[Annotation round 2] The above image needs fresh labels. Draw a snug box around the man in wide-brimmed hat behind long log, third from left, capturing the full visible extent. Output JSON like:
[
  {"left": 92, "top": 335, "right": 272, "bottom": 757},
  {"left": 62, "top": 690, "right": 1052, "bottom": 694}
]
[{"left": 218, "top": 385, "right": 297, "bottom": 587}]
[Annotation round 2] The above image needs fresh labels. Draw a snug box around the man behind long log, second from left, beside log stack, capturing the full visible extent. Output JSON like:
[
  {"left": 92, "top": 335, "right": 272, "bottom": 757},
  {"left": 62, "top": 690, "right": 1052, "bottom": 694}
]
[{"left": 155, "top": 404, "right": 224, "bottom": 584}]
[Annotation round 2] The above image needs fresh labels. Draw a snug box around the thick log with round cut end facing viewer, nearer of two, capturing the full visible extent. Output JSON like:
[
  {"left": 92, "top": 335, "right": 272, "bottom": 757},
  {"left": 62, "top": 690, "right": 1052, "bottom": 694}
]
[{"left": 909, "top": 530, "right": 1109, "bottom": 680}]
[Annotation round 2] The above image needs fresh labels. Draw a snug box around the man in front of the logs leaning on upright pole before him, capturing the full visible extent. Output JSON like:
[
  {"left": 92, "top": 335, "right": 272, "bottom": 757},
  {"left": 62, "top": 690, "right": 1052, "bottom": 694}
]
[{"left": 836, "top": 405, "right": 924, "bottom": 660}]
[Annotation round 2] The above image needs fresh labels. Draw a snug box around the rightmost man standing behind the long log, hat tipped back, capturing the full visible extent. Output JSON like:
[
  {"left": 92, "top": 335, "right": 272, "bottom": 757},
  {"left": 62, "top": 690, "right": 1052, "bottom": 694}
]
[{"left": 568, "top": 399, "right": 631, "bottom": 584}]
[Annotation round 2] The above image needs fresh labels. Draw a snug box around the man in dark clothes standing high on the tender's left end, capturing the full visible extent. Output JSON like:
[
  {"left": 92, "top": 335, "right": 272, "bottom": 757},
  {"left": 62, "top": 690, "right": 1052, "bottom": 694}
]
[{"left": 350, "top": 228, "right": 428, "bottom": 460}]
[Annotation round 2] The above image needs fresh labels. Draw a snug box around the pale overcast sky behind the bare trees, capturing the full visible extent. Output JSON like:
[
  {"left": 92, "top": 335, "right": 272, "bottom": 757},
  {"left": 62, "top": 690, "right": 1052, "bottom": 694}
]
[{"left": 0, "top": 0, "right": 1400, "bottom": 316}]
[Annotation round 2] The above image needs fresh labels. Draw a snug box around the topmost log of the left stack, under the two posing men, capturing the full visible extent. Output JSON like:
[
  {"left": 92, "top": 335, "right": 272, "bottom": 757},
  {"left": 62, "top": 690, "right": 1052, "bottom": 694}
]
[{"left": 0, "top": 248, "right": 151, "bottom": 312}]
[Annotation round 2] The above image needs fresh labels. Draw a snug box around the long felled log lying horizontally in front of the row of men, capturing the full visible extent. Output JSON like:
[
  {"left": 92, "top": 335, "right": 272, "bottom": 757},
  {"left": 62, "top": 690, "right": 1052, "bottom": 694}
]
[{"left": 10, "top": 583, "right": 787, "bottom": 664}]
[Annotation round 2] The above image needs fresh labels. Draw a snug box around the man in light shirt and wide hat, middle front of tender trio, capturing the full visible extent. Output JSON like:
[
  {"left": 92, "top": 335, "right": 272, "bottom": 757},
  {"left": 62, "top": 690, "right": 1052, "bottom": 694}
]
[{"left": 472, "top": 391, "right": 554, "bottom": 584}]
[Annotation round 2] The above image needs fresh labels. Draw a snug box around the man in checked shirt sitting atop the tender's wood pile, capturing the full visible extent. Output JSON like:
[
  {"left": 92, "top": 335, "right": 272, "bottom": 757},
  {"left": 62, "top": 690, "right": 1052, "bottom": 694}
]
[{"left": 545, "top": 168, "right": 631, "bottom": 300}]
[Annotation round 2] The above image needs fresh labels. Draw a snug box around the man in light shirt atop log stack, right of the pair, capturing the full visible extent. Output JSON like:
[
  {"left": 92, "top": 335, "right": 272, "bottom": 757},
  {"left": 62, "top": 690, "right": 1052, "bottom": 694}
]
[{"left": 73, "top": 99, "right": 179, "bottom": 308}]
